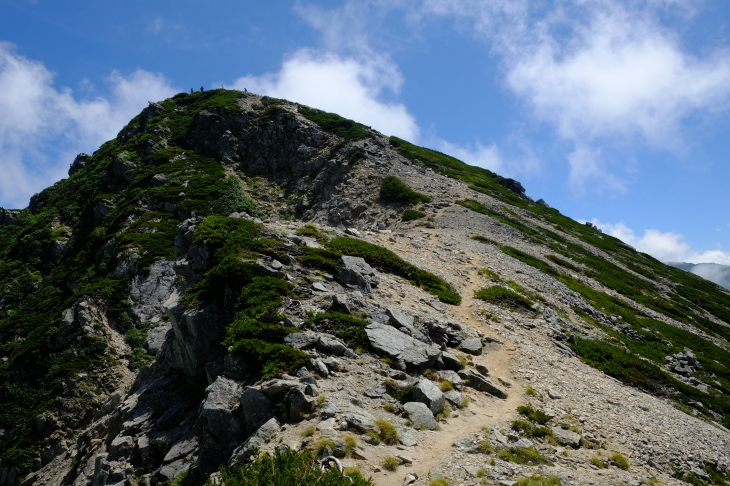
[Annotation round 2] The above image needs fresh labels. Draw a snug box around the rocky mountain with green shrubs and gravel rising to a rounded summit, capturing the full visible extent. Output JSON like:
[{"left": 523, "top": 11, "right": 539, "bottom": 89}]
[{"left": 0, "top": 90, "right": 730, "bottom": 486}]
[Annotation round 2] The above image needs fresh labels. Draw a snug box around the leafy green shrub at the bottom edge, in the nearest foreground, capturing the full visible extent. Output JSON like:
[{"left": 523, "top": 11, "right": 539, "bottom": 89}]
[{"left": 216, "top": 449, "right": 373, "bottom": 486}]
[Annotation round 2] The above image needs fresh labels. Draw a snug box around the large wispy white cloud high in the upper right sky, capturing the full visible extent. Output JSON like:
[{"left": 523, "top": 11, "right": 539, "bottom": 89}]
[{"left": 420, "top": 0, "right": 730, "bottom": 192}]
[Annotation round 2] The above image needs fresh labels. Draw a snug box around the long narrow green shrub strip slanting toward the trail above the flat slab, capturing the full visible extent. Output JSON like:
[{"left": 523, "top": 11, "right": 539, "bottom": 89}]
[{"left": 326, "top": 236, "right": 461, "bottom": 305}]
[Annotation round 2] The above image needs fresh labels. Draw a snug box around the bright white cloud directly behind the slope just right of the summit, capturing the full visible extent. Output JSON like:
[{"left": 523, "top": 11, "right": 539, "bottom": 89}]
[{"left": 233, "top": 49, "right": 419, "bottom": 140}]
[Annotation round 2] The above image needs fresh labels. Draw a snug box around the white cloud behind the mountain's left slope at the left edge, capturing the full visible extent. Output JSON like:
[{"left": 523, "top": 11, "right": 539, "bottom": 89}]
[{"left": 0, "top": 42, "right": 177, "bottom": 207}]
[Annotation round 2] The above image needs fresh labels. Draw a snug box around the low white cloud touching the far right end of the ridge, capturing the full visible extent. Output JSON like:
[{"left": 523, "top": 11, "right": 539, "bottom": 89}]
[{"left": 593, "top": 219, "right": 730, "bottom": 265}]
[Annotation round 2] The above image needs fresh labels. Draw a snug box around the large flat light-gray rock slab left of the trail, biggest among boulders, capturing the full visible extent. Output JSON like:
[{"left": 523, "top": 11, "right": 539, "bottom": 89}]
[{"left": 365, "top": 324, "right": 441, "bottom": 368}]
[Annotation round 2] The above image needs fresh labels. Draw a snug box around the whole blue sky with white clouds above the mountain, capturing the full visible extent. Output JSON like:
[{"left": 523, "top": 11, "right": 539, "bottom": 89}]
[{"left": 0, "top": 0, "right": 730, "bottom": 264}]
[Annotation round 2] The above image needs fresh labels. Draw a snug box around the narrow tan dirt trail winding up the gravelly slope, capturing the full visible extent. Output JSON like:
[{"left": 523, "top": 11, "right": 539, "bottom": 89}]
[{"left": 374, "top": 254, "right": 524, "bottom": 486}]
